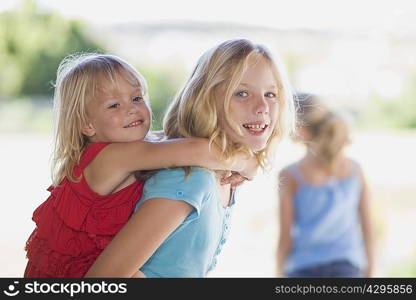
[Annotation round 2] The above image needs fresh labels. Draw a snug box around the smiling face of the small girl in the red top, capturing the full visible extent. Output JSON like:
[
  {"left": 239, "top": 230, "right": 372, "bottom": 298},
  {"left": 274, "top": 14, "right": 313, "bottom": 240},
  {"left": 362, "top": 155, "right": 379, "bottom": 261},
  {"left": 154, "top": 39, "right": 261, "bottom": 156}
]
[{"left": 82, "top": 75, "right": 151, "bottom": 142}]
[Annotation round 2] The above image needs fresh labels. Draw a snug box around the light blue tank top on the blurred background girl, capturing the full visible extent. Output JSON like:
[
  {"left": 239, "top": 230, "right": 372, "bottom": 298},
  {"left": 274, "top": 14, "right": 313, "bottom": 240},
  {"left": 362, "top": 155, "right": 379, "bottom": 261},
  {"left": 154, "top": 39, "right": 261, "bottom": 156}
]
[{"left": 285, "top": 164, "right": 366, "bottom": 273}]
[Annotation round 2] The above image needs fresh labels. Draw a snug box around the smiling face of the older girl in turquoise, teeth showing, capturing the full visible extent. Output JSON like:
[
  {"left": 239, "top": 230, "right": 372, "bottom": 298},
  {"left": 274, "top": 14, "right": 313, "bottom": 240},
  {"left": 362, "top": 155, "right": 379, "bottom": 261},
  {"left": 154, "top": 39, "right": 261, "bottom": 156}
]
[{"left": 218, "top": 57, "right": 279, "bottom": 151}]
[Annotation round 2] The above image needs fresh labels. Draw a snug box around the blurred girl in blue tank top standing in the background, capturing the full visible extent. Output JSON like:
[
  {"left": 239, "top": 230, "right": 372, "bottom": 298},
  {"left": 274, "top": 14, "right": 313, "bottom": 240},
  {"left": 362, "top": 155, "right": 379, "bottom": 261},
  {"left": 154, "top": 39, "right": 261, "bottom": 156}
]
[{"left": 277, "top": 95, "right": 373, "bottom": 277}]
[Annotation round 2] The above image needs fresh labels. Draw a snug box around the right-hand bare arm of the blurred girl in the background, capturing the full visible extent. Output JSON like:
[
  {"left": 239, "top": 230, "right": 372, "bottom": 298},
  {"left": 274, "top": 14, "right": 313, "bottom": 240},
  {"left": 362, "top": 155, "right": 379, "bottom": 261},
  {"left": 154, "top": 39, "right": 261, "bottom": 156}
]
[{"left": 359, "top": 164, "right": 374, "bottom": 277}]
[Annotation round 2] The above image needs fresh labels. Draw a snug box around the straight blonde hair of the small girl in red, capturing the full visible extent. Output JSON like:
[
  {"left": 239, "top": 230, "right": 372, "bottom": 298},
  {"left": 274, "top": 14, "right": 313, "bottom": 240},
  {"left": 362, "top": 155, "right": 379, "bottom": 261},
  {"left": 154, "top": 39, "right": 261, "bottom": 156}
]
[{"left": 52, "top": 53, "right": 148, "bottom": 186}]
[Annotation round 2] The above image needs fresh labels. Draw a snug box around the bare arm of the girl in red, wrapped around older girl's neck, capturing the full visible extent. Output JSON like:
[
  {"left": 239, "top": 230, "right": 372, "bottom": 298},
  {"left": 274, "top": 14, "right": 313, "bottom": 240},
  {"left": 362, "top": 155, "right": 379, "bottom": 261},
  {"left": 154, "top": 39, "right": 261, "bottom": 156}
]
[{"left": 84, "top": 138, "right": 258, "bottom": 195}]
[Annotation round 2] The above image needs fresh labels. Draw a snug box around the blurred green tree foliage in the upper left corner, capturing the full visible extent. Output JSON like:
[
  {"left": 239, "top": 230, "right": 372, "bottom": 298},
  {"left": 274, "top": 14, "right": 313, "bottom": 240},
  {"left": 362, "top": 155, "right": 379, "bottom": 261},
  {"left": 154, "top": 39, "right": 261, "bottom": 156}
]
[{"left": 0, "top": 0, "right": 103, "bottom": 97}]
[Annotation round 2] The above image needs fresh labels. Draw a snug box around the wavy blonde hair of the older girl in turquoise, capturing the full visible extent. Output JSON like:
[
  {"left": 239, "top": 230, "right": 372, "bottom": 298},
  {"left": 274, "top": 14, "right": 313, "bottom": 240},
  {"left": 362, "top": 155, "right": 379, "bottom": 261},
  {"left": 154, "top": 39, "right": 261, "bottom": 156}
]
[{"left": 163, "top": 39, "right": 294, "bottom": 168}]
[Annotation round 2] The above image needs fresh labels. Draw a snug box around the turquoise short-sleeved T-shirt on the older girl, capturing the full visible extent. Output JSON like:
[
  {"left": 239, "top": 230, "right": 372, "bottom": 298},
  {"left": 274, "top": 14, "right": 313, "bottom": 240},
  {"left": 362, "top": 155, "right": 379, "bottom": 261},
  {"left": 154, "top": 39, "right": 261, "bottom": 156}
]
[{"left": 136, "top": 167, "right": 234, "bottom": 277}]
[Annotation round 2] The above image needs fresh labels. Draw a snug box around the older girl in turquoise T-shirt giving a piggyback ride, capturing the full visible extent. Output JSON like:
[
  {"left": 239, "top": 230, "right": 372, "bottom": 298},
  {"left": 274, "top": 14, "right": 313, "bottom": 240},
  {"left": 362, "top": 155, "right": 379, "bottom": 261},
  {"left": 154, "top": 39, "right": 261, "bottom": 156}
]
[{"left": 87, "top": 39, "right": 293, "bottom": 277}]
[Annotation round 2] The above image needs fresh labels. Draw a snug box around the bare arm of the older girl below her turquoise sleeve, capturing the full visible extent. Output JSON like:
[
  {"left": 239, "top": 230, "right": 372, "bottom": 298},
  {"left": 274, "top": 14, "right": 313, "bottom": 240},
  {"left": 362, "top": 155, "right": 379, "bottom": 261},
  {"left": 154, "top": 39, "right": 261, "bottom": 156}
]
[{"left": 85, "top": 198, "right": 192, "bottom": 277}]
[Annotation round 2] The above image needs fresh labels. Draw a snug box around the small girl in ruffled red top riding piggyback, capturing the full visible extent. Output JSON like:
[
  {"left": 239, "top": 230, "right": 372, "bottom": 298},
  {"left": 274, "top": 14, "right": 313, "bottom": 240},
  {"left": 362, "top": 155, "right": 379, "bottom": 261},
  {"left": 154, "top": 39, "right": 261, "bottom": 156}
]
[{"left": 24, "top": 54, "right": 257, "bottom": 277}]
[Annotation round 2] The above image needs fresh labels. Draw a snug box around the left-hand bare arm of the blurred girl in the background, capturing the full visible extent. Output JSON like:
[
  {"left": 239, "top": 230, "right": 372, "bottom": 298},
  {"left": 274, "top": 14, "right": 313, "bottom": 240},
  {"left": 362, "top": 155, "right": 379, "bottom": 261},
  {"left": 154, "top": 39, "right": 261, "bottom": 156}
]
[{"left": 277, "top": 169, "right": 297, "bottom": 277}]
